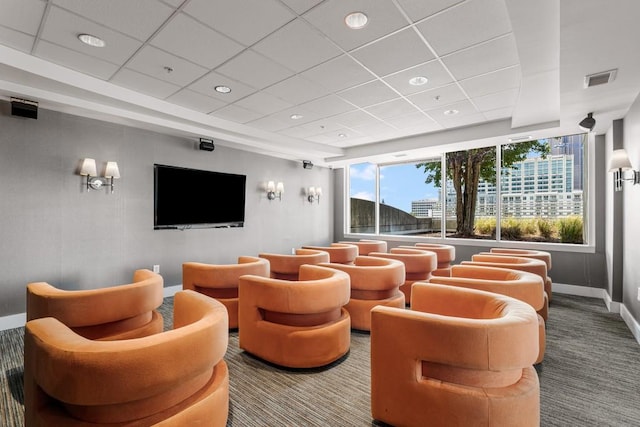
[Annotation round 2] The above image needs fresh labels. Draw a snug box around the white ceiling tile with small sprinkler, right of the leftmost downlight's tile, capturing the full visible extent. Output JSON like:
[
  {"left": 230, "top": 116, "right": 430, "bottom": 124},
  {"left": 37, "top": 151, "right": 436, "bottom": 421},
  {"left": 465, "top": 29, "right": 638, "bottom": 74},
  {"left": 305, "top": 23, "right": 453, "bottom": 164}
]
[{"left": 127, "top": 45, "right": 207, "bottom": 86}]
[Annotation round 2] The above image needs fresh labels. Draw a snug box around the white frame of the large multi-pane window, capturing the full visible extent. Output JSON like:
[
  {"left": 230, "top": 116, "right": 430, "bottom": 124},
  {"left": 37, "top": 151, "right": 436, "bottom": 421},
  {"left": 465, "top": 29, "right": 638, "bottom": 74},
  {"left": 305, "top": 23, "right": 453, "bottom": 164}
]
[{"left": 344, "top": 133, "right": 596, "bottom": 253}]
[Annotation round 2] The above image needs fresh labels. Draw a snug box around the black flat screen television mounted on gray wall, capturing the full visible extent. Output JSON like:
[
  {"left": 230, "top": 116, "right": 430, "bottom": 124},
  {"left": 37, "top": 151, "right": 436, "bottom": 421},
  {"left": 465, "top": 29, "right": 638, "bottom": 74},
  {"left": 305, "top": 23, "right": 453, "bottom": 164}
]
[{"left": 153, "top": 164, "right": 247, "bottom": 230}]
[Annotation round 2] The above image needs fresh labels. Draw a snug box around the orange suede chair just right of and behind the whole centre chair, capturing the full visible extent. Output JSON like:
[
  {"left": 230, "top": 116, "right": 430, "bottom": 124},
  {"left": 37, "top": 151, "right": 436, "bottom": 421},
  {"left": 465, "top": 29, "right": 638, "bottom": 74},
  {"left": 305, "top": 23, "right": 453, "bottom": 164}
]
[{"left": 320, "top": 256, "right": 405, "bottom": 331}]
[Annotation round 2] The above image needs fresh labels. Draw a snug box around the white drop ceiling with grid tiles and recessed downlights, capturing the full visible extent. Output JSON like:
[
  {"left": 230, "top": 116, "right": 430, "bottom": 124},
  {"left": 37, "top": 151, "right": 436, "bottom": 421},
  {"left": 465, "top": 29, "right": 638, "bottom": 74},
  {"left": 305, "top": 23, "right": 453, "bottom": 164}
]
[{"left": 0, "top": 0, "right": 640, "bottom": 165}]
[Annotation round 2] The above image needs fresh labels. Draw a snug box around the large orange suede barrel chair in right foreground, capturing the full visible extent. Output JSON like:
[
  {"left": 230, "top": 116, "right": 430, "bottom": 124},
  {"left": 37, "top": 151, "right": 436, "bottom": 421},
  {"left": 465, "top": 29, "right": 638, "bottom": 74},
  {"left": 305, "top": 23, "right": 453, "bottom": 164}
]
[{"left": 371, "top": 283, "right": 540, "bottom": 427}]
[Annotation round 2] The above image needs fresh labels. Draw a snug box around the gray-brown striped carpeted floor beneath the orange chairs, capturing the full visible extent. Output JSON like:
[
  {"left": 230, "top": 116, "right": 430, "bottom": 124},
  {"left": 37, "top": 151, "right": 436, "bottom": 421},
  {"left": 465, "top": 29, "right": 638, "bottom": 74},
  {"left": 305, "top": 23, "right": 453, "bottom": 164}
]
[{"left": 0, "top": 294, "right": 640, "bottom": 427}]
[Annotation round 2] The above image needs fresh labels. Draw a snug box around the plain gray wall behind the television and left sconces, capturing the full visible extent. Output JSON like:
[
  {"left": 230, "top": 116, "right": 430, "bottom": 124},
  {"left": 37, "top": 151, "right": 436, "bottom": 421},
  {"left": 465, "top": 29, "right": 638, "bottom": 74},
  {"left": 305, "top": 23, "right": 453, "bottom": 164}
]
[{"left": 0, "top": 103, "right": 334, "bottom": 316}]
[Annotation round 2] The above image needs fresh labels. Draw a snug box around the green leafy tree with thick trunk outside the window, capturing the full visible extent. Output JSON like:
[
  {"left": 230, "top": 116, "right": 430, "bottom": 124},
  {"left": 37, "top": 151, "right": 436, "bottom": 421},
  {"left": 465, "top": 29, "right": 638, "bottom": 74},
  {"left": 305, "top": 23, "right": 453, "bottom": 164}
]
[{"left": 416, "top": 140, "right": 550, "bottom": 237}]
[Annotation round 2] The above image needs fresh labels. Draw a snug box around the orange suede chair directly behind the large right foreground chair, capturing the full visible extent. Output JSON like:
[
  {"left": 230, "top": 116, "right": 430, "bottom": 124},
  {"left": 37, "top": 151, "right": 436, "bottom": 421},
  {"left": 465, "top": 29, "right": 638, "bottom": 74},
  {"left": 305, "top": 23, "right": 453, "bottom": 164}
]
[{"left": 429, "top": 265, "right": 547, "bottom": 363}]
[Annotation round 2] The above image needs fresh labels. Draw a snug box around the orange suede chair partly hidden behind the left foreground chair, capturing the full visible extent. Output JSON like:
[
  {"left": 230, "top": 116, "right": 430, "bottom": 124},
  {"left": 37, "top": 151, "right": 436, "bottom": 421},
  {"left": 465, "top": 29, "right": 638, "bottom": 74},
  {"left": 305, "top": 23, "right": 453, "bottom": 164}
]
[{"left": 27, "top": 269, "right": 163, "bottom": 340}]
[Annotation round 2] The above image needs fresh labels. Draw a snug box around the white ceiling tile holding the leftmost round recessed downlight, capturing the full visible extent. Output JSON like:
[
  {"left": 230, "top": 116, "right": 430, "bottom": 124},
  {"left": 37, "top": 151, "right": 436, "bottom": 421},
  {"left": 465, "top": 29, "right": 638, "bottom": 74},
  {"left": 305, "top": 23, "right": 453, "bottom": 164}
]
[{"left": 41, "top": 6, "right": 141, "bottom": 65}]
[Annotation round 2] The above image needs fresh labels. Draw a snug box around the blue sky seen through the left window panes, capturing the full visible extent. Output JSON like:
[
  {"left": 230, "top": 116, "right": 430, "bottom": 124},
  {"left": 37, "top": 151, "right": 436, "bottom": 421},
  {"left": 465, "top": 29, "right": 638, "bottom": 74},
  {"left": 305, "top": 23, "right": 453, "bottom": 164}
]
[{"left": 349, "top": 163, "right": 439, "bottom": 212}]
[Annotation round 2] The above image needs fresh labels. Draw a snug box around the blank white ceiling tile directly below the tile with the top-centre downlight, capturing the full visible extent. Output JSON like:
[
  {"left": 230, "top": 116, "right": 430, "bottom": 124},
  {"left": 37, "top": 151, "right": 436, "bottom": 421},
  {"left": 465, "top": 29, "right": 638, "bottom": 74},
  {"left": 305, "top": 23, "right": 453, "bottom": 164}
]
[{"left": 302, "top": 55, "right": 375, "bottom": 92}]
